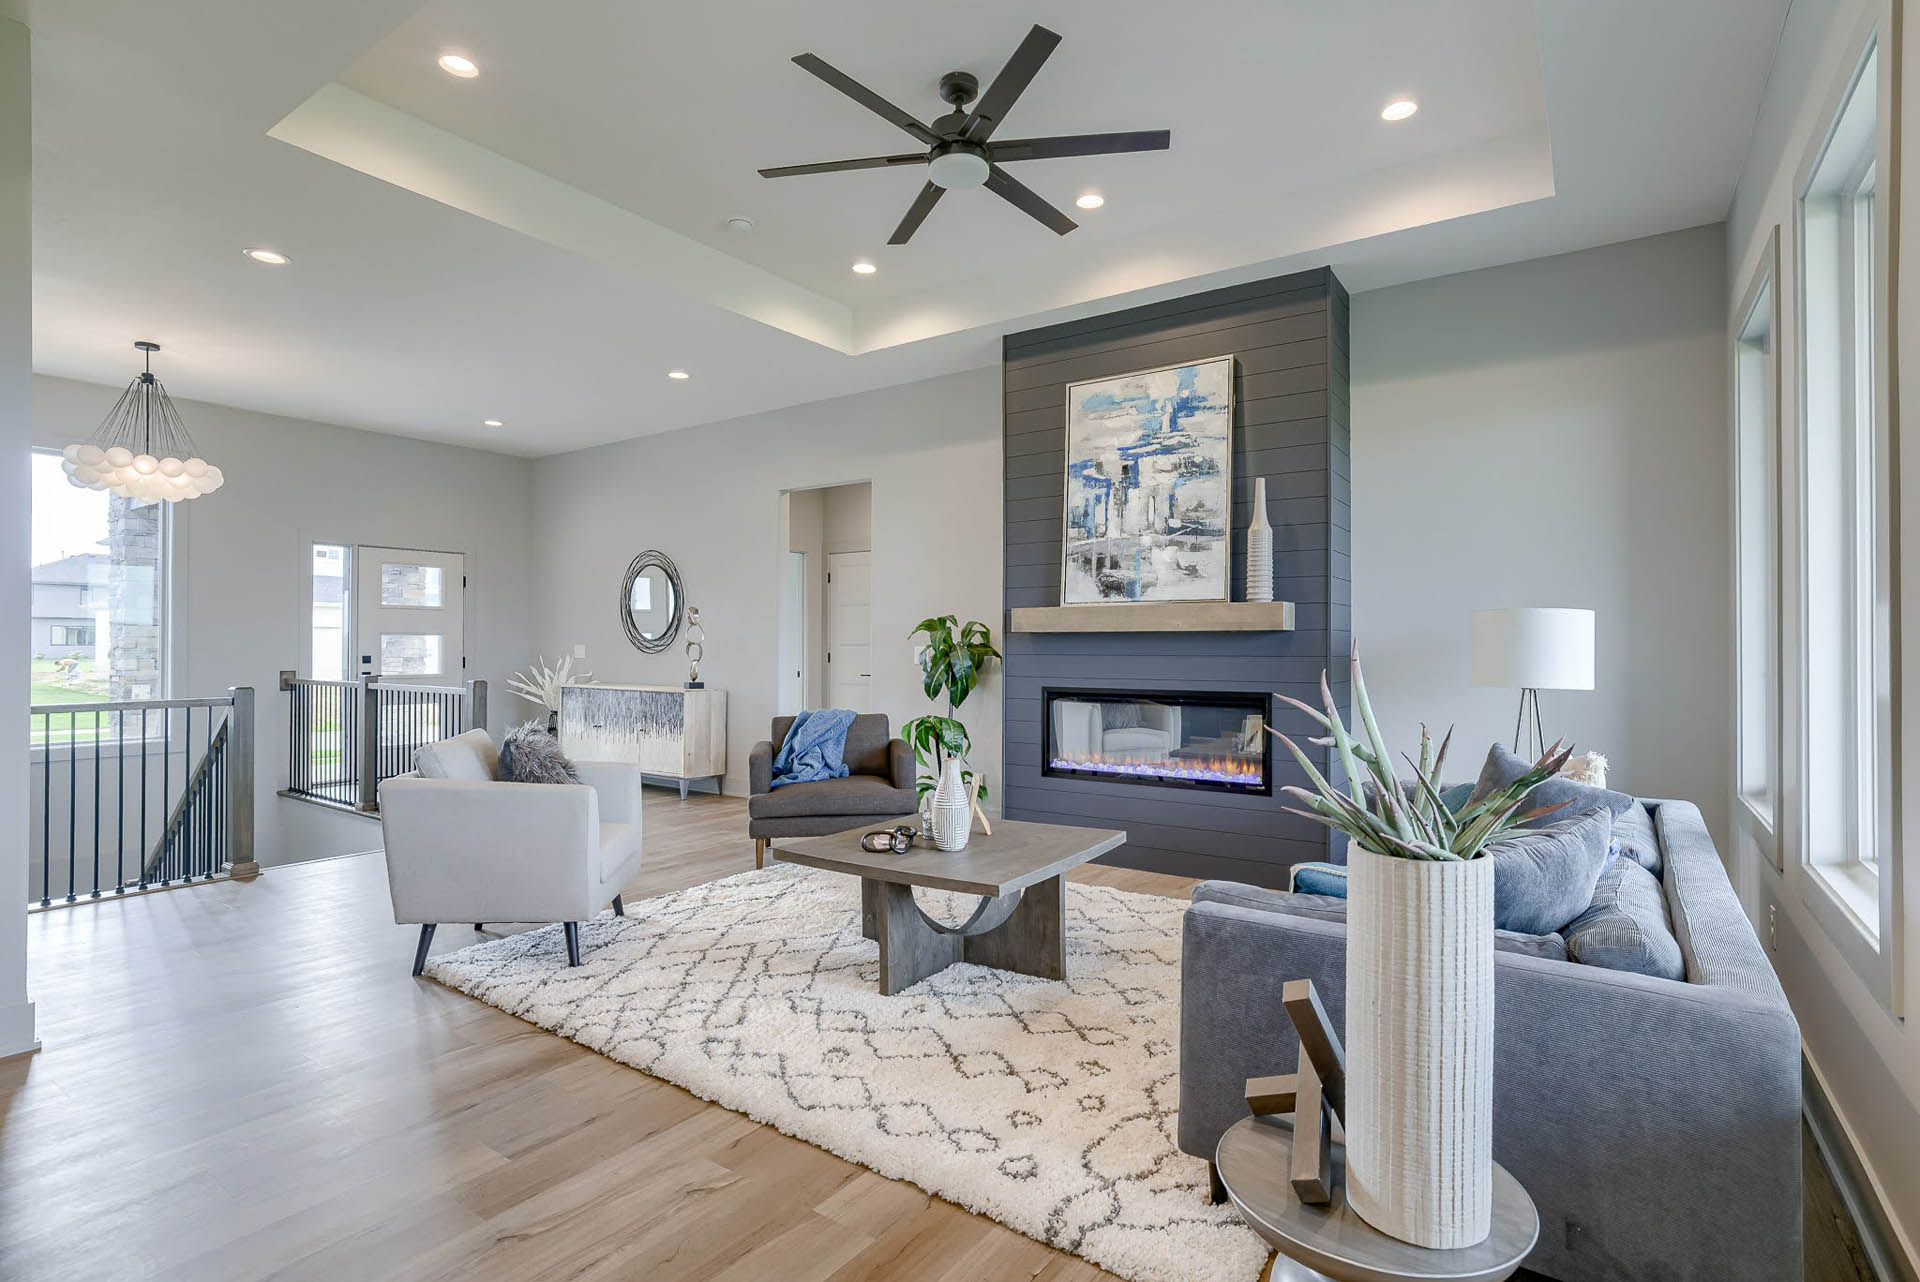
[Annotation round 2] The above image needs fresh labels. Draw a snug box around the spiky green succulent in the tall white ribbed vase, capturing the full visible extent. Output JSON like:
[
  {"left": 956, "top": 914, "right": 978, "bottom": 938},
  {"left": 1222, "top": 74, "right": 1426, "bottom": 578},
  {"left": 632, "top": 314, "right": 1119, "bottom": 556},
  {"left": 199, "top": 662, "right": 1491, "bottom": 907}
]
[{"left": 1269, "top": 645, "right": 1572, "bottom": 862}]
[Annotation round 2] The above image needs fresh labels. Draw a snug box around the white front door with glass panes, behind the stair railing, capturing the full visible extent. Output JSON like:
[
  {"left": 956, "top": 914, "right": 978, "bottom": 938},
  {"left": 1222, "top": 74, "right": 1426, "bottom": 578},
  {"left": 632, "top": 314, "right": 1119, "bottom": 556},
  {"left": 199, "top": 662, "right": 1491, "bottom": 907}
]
[{"left": 353, "top": 547, "right": 467, "bottom": 685}]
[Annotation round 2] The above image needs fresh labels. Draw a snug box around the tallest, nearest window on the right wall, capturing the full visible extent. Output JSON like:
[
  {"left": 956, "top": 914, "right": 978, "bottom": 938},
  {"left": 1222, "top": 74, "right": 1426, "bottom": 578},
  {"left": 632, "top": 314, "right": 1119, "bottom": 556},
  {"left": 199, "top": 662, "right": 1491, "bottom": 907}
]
[{"left": 1799, "top": 48, "right": 1893, "bottom": 940}]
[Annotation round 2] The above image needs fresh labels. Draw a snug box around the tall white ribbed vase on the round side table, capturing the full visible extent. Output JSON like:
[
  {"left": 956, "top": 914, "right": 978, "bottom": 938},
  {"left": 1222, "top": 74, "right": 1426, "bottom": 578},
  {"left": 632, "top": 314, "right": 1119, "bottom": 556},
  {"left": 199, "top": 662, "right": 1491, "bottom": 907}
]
[{"left": 1346, "top": 844, "right": 1494, "bottom": 1249}]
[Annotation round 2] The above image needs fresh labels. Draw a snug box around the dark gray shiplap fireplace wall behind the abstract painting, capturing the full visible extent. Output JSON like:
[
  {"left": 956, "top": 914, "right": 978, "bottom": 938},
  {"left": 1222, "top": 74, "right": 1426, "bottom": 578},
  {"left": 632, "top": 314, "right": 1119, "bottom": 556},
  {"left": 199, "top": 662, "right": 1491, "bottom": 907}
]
[{"left": 1002, "top": 269, "right": 1352, "bottom": 887}]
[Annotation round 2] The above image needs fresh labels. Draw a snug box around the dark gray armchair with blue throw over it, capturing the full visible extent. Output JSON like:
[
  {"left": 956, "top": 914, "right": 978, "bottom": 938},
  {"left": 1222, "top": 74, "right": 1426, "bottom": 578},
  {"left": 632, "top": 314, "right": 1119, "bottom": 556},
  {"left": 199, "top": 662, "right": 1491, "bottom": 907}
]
[{"left": 747, "top": 712, "right": 920, "bottom": 867}]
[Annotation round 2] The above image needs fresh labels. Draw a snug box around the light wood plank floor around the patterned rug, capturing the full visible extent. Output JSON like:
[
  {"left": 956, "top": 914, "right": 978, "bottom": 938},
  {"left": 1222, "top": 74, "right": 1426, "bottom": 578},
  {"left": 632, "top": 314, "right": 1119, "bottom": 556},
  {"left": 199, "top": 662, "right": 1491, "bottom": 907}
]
[{"left": 0, "top": 789, "right": 1866, "bottom": 1282}]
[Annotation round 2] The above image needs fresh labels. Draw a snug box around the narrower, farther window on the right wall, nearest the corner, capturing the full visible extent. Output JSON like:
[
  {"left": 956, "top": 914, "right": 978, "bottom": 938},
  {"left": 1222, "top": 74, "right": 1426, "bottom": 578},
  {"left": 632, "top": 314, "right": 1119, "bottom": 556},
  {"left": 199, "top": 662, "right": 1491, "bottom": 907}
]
[{"left": 1732, "top": 234, "right": 1780, "bottom": 867}]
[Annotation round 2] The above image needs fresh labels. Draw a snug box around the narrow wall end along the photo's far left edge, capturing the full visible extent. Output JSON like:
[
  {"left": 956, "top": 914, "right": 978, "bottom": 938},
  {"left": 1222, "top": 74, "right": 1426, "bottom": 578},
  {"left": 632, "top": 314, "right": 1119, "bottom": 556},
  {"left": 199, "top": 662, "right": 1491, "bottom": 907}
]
[{"left": 0, "top": 17, "right": 35, "bottom": 1056}]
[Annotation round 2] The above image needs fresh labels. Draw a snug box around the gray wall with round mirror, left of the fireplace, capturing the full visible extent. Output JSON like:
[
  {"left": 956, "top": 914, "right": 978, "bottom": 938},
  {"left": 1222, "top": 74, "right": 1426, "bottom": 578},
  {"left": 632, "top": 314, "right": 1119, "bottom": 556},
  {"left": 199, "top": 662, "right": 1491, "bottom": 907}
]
[{"left": 532, "top": 368, "right": 1000, "bottom": 794}]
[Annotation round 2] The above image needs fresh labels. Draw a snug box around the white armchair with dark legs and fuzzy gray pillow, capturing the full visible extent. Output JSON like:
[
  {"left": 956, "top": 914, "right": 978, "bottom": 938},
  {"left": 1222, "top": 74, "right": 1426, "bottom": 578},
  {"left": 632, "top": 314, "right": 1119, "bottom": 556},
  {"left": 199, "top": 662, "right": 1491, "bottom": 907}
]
[{"left": 380, "top": 731, "right": 641, "bottom": 975}]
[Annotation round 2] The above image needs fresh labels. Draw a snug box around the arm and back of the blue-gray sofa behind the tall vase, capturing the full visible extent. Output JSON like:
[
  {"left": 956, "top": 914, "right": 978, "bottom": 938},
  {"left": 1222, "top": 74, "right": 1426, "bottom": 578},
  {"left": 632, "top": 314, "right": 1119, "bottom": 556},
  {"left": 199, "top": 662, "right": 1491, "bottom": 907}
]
[{"left": 1179, "top": 800, "right": 1801, "bottom": 1282}]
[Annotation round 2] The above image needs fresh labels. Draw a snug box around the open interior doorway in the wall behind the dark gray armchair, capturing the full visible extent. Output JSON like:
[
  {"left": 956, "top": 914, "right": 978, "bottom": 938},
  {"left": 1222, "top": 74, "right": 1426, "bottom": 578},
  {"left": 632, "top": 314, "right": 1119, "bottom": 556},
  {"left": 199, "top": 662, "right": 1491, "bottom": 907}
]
[{"left": 776, "top": 482, "right": 874, "bottom": 716}]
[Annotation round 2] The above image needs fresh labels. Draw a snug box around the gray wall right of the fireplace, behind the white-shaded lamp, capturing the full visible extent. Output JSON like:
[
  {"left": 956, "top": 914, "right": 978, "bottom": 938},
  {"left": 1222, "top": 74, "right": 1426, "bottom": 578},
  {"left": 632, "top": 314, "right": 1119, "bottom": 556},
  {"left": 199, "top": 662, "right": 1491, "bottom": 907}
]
[{"left": 1354, "top": 225, "right": 1732, "bottom": 839}]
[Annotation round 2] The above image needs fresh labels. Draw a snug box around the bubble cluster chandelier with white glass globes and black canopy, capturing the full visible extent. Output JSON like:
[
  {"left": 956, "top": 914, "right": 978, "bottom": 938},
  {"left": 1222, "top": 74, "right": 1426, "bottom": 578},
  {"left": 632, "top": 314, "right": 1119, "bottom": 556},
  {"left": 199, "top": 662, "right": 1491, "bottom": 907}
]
[{"left": 60, "top": 340, "right": 227, "bottom": 503}]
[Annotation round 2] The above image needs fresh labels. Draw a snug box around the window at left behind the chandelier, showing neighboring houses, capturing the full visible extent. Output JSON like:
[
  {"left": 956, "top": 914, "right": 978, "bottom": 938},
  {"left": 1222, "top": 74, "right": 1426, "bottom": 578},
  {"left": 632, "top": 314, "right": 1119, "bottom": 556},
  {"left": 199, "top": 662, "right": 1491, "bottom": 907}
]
[{"left": 29, "top": 451, "right": 167, "bottom": 737}]
